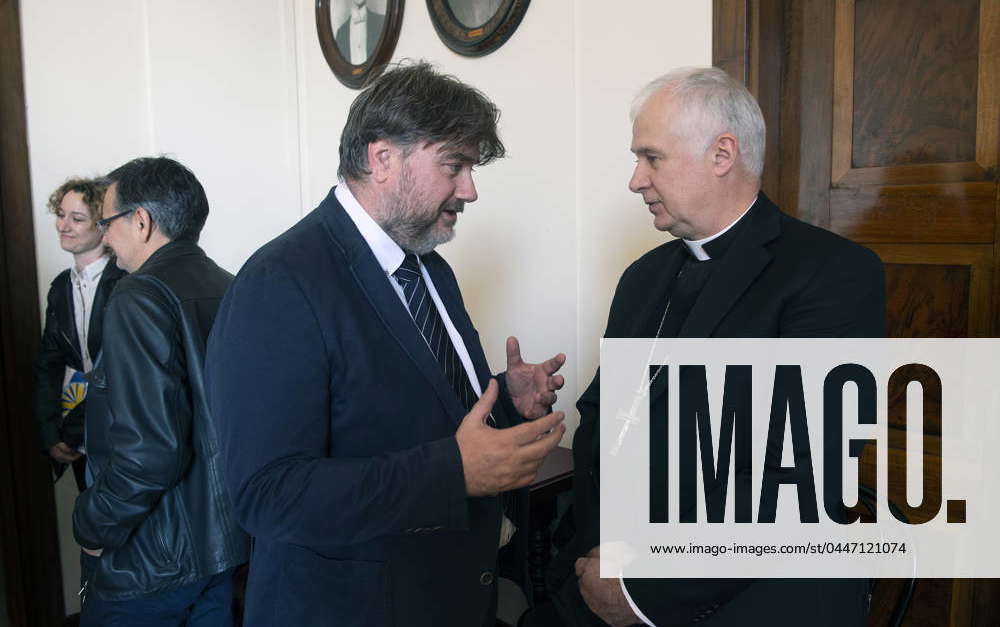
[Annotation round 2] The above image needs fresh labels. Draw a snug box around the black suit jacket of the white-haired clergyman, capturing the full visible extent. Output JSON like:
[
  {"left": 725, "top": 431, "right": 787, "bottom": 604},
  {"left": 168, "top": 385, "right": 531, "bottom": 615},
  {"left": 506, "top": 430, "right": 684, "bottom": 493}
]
[{"left": 549, "top": 193, "right": 885, "bottom": 627}]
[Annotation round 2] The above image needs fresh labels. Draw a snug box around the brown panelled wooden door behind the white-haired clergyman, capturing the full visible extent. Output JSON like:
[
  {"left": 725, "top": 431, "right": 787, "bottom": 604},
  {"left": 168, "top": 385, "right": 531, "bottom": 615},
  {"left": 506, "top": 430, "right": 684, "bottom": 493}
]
[{"left": 713, "top": 0, "right": 1000, "bottom": 627}]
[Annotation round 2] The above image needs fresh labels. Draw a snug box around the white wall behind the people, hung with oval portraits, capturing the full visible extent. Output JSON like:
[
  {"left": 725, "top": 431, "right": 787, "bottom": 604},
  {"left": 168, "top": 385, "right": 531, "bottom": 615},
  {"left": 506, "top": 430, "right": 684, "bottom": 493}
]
[{"left": 21, "top": 0, "right": 711, "bottom": 609}]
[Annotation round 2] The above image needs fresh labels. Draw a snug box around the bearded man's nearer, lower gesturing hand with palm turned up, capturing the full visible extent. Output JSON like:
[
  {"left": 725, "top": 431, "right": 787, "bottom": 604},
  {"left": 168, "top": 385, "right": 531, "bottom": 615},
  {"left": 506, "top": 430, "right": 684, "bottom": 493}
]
[{"left": 455, "top": 379, "right": 566, "bottom": 496}]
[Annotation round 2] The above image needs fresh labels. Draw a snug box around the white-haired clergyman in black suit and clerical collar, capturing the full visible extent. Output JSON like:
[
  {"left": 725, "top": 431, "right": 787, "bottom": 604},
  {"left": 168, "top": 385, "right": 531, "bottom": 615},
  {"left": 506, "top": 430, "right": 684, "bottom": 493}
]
[{"left": 522, "top": 68, "right": 885, "bottom": 627}]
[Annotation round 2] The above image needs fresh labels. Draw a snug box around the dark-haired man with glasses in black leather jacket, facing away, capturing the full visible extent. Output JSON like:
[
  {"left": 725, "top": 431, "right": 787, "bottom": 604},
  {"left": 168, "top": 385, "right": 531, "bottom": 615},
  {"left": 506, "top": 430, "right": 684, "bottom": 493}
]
[{"left": 73, "top": 157, "right": 249, "bottom": 627}]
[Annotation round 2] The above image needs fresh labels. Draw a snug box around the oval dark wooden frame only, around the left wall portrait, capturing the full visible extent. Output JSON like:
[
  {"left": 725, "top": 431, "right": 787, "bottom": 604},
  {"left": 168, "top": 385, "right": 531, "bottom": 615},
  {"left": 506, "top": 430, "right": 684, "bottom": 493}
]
[{"left": 316, "top": 0, "right": 403, "bottom": 89}]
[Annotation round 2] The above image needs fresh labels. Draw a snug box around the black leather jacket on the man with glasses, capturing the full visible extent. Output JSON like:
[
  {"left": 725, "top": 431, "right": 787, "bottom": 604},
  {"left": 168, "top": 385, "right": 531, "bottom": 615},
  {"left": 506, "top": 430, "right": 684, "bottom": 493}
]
[{"left": 73, "top": 241, "right": 248, "bottom": 600}]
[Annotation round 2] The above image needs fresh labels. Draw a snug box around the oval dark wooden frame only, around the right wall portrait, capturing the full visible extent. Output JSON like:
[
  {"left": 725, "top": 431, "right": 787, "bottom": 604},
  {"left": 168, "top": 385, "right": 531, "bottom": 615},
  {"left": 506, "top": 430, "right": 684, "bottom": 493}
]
[{"left": 427, "top": 0, "right": 531, "bottom": 57}]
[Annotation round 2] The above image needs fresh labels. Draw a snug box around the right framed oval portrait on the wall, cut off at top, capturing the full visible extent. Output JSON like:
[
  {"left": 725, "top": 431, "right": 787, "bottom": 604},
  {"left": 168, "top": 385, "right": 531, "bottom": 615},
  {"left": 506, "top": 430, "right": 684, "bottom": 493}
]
[{"left": 427, "top": 0, "right": 530, "bottom": 57}]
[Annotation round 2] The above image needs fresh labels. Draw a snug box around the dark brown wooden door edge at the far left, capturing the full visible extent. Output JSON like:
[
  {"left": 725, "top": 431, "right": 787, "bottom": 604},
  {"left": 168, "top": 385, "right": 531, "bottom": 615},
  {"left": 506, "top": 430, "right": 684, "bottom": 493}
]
[{"left": 0, "top": 0, "right": 65, "bottom": 627}]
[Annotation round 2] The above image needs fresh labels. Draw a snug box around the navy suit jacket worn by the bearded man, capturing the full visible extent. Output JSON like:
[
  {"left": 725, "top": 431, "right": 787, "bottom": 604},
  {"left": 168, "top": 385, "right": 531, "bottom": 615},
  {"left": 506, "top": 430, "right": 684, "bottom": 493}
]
[{"left": 207, "top": 191, "right": 510, "bottom": 627}]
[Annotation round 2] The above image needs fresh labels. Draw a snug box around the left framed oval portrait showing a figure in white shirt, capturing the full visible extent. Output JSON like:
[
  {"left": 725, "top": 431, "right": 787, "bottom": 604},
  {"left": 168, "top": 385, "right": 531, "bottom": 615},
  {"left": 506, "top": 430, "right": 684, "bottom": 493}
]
[{"left": 316, "top": 0, "right": 403, "bottom": 89}]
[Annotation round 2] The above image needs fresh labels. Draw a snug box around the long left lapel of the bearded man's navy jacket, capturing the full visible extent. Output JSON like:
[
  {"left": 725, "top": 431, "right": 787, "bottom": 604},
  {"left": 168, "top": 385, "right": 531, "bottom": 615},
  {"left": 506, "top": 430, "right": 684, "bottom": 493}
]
[{"left": 320, "top": 191, "right": 468, "bottom": 423}]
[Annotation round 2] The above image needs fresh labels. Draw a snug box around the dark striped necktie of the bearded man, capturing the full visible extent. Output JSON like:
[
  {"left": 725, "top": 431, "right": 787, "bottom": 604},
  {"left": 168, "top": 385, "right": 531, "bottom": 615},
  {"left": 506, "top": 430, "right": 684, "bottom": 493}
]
[{"left": 392, "top": 253, "right": 478, "bottom": 411}]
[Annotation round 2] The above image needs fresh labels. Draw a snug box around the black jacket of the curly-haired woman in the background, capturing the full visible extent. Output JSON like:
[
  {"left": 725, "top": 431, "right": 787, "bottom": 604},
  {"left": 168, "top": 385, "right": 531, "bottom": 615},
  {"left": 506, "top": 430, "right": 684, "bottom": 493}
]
[{"left": 35, "top": 257, "right": 125, "bottom": 454}]
